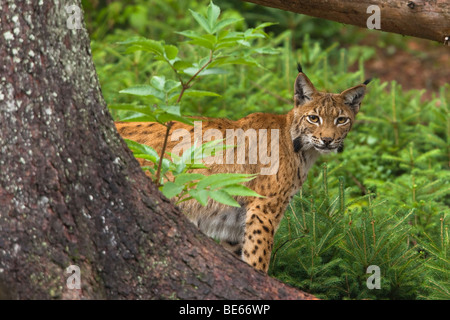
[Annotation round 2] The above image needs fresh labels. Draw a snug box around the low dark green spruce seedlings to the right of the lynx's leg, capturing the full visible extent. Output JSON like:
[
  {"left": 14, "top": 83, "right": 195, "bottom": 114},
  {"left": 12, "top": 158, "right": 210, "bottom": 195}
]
[{"left": 270, "top": 165, "right": 450, "bottom": 299}]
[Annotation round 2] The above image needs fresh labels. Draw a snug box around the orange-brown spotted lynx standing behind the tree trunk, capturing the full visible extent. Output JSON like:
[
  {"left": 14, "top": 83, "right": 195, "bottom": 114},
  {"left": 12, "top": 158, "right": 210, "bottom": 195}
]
[{"left": 116, "top": 65, "right": 370, "bottom": 272}]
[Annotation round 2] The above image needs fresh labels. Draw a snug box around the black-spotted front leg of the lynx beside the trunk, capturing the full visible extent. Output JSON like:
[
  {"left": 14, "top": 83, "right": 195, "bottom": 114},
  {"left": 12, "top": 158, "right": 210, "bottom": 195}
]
[{"left": 242, "top": 203, "right": 279, "bottom": 272}]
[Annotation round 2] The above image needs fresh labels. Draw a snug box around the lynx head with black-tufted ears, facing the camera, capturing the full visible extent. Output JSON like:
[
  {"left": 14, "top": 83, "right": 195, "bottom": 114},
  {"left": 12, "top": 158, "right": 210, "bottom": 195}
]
[{"left": 291, "top": 65, "right": 370, "bottom": 153}]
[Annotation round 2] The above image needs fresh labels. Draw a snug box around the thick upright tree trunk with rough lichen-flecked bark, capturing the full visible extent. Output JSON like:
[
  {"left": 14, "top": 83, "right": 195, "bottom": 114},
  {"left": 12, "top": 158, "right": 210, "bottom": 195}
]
[{"left": 0, "top": 0, "right": 313, "bottom": 299}]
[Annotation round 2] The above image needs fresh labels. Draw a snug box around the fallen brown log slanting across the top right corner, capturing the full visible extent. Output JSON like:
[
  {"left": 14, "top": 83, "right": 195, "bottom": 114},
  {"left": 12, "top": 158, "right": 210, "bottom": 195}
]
[{"left": 245, "top": 0, "right": 450, "bottom": 43}]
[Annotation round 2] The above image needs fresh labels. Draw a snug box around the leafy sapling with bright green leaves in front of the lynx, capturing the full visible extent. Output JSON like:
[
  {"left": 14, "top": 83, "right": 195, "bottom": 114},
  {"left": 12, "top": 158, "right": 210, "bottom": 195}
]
[{"left": 109, "top": 2, "right": 267, "bottom": 207}]
